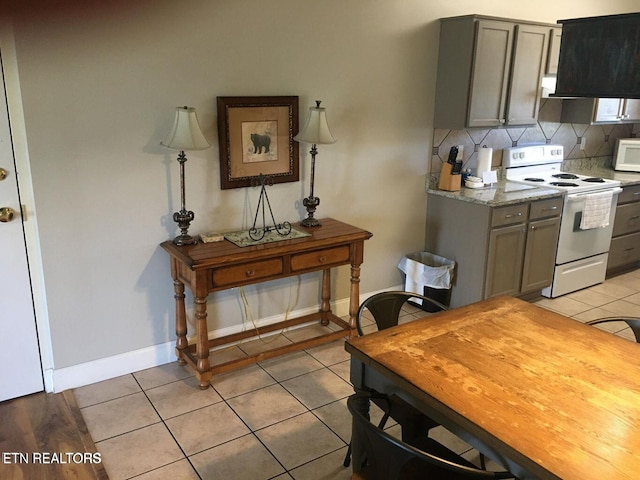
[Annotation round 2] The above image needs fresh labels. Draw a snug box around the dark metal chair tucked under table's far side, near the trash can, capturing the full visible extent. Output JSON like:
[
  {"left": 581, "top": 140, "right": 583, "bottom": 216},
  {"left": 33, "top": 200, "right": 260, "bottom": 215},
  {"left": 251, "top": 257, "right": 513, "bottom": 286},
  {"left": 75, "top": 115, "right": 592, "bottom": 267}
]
[{"left": 343, "top": 291, "right": 447, "bottom": 467}]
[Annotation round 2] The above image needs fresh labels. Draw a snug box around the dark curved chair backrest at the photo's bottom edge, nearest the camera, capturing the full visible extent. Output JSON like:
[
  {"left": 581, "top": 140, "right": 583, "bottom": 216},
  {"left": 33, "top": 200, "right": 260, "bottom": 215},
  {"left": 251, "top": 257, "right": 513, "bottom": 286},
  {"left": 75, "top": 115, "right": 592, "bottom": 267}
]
[{"left": 347, "top": 395, "right": 513, "bottom": 480}]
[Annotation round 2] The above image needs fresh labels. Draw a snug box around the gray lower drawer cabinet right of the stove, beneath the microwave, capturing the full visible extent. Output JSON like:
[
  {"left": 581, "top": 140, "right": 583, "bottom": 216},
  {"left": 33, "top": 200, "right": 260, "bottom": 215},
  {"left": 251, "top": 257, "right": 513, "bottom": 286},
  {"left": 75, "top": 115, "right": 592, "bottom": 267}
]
[{"left": 607, "top": 185, "right": 640, "bottom": 274}]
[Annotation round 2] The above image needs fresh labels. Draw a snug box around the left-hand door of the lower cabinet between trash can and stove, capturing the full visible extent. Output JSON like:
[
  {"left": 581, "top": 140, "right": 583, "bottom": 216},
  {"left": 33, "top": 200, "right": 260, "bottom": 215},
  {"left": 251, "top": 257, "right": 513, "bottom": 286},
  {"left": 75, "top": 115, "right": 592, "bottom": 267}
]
[{"left": 484, "top": 224, "right": 526, "bottom": 298}]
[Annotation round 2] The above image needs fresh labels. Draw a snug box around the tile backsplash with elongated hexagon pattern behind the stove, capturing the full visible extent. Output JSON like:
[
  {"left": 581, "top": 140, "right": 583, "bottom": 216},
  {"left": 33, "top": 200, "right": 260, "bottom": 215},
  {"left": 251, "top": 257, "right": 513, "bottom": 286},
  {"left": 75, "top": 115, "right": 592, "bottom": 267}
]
[{"left": 430, "top": 98, "right": 640, "bottom": 181}]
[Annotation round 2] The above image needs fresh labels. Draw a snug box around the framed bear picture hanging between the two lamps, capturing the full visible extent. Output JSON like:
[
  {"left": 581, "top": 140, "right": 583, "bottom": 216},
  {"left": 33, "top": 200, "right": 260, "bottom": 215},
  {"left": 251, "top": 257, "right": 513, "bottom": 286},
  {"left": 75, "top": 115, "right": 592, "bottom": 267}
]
[{"left": 218, "top": 97, "right": 300, "bottom": 190}]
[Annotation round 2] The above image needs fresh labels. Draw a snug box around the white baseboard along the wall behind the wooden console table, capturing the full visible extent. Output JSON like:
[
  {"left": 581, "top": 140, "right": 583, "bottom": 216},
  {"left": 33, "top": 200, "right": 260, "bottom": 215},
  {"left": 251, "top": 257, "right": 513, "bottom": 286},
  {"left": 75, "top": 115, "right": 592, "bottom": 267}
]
[{"left": 45, "top": 286, "right": 401, "bottom": 393}]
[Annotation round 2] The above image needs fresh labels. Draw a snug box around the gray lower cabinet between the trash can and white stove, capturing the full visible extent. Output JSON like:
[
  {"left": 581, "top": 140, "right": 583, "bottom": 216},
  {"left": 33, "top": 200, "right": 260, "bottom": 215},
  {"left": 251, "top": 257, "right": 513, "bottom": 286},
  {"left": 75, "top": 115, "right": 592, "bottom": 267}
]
[{"left": 426, "top": 194, "right": 562, "bottom": 307}]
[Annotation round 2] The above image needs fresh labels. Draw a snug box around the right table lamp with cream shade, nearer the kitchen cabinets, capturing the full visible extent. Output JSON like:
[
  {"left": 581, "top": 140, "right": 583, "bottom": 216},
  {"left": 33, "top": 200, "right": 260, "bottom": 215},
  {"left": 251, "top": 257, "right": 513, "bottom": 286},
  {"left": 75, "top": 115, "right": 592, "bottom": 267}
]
[{"left": 293, "top": 100, "right": 336, "bottom": 227}]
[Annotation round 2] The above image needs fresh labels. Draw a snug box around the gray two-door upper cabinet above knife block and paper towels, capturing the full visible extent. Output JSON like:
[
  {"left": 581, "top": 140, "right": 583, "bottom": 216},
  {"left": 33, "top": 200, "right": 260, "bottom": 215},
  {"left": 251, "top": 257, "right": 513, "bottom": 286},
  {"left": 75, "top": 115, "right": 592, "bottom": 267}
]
[{"left": 434, "top": 15, "right": 554, "bottom": 130}]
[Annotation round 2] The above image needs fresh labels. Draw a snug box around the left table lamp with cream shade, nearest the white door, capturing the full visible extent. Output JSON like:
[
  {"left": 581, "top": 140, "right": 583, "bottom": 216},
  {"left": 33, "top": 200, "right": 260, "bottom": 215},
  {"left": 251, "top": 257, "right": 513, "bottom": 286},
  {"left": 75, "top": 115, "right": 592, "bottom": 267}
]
[{"left": 160, "top": 106, "right": 210, "bottom": 245}]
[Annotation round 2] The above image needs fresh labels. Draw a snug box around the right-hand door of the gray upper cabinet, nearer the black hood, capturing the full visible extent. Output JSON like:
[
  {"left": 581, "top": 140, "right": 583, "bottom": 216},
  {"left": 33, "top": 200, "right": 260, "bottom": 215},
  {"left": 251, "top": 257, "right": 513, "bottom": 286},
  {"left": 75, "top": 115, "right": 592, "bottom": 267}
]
[{"left": 506, "top": 25, "right": 550, "bottom": 125}]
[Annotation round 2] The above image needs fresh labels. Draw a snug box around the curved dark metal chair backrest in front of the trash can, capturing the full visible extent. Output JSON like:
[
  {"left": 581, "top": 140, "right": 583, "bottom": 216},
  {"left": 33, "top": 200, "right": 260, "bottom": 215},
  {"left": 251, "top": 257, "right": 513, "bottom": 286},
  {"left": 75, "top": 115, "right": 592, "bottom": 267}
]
[{"left": 356, "top": 291, "right": 447, "bottom": 335}]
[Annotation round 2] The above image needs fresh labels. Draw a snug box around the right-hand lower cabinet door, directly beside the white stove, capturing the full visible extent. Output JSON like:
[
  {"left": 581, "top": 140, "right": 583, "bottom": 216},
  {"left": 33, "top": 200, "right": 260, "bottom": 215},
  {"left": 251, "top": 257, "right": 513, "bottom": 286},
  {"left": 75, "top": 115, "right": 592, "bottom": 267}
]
[{"left": 520, "top": 217, "right": 560, "bottom": 293}]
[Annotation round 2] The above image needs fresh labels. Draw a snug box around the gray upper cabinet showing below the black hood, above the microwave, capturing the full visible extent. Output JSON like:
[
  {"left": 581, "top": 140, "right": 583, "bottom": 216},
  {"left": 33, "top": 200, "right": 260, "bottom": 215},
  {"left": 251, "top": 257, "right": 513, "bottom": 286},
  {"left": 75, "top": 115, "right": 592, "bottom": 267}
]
[{"left": 560, "top": 98, "right": 640, "bottom": 124}]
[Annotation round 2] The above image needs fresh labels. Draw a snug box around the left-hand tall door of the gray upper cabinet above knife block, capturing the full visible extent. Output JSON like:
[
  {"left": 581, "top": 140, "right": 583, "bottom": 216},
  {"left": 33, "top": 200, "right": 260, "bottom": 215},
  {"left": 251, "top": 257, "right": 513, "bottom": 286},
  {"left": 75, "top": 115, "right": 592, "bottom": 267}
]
[{"left": 468, "top": 20, "right": 515, "bottom": 127}]
